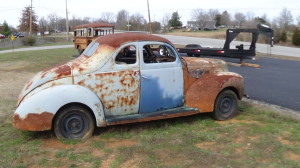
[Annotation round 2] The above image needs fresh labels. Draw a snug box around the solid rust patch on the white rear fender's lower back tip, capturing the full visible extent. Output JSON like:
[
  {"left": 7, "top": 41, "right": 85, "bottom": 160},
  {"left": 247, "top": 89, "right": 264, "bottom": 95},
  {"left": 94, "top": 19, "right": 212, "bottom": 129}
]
[{"left": 13, "top": 112, "right": 54, "bottom": 131}]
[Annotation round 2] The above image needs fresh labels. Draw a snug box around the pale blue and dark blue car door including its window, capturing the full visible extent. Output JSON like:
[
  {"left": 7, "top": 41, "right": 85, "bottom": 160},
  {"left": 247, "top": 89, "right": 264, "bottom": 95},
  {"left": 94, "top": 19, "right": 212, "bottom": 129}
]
[{"left": 139, "top": 42, "right": 184, "bottom": 114}]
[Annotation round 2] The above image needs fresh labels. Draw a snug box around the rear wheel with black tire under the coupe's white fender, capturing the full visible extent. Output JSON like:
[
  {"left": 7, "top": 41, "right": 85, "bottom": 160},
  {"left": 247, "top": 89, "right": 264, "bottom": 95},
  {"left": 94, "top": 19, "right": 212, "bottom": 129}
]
[{"left": 54, "top": 105, "right": 95, "bottom": 139}]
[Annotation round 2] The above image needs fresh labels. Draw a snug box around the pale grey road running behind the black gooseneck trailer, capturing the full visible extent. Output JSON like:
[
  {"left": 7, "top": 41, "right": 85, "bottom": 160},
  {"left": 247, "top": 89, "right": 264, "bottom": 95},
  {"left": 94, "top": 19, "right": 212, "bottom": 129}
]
[{"left": 159, "top": 35, "right": 300, "bottom": 57}]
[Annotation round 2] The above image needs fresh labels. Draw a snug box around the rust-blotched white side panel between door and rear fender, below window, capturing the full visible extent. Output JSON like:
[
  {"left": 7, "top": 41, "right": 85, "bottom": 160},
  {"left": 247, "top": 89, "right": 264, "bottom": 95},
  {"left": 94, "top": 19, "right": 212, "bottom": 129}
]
[{"left": 76, "top": 70, "right": 140, "bottom": 115}]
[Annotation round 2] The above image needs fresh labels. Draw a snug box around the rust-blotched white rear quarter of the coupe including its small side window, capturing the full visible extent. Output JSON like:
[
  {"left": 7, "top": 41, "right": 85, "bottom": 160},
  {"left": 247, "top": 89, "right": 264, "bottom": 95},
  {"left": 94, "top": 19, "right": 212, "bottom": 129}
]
[{"left": 75, "top": 43, "right": 140, "bottom": 117}]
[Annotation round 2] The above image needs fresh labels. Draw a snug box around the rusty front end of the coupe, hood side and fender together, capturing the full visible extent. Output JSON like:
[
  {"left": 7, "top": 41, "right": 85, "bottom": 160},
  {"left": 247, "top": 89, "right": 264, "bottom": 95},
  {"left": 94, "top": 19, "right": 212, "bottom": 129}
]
[{"left": 183, "top": 58, "right": 244, "bottom": 112}]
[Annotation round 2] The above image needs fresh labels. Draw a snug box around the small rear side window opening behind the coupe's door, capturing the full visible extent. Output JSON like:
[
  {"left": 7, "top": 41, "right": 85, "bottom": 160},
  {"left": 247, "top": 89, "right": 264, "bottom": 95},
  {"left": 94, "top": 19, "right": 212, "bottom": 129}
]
[{"left": 115, "top": 45, "right": 136, "bottom": 64}]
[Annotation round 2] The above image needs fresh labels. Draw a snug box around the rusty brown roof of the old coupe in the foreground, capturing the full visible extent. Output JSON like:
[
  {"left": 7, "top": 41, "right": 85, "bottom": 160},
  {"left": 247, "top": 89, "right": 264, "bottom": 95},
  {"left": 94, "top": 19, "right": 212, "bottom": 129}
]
[{"left": 97, "top": 33, "right": 172, "bottom": 48}]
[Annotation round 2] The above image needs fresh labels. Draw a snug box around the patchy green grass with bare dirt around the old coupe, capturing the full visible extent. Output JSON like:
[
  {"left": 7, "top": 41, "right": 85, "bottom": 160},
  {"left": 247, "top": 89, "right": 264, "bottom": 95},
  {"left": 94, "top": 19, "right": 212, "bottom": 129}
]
[{"left": 0, "top": 48, "right": 300, "bottom": 168}]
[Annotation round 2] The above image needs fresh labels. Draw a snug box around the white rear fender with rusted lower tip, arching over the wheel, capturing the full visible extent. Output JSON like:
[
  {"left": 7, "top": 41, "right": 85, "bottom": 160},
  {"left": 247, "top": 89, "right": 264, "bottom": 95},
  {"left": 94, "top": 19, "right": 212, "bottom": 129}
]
[{"left": 13, "top": 85, "right": 106, "bottom": 131}]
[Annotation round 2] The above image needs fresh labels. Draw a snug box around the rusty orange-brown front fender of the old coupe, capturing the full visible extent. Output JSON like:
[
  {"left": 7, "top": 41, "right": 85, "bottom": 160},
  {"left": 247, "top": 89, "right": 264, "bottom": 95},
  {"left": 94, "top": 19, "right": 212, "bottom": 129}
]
[{"left": 185, "top": 72, "right": 244, "bottom": 112}]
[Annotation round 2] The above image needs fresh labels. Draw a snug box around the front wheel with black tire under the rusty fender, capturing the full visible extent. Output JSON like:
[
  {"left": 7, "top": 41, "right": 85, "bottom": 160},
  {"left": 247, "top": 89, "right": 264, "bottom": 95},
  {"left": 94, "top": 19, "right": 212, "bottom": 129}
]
[{"left": 213, "top": 90, "right": 238, "bottom": 121}]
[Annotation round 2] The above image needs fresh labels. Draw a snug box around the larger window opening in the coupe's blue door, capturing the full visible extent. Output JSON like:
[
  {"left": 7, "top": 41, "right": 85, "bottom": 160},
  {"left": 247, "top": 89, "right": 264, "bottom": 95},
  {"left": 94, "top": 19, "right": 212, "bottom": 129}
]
[{"left": 143, "top": 44, "right": 176, "bottom": 64}]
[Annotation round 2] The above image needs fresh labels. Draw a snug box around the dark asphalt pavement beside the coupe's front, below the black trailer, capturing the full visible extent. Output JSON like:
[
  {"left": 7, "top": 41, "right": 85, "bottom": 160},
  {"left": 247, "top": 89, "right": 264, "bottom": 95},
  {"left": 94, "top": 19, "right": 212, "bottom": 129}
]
[{"left": 207, "top": 57, "right": 300, "bottom": 112}]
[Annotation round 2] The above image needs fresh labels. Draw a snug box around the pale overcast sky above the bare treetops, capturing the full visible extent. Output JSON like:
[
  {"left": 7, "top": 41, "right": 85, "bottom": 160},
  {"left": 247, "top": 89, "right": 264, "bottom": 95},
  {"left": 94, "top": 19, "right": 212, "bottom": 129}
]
[{"left": 0, "top": 0, "right": 300, "bottom": 27}]
